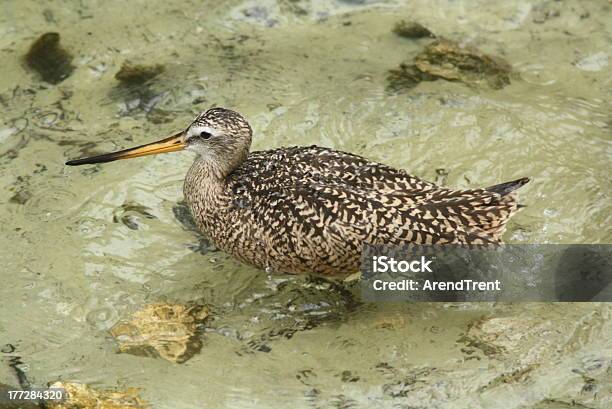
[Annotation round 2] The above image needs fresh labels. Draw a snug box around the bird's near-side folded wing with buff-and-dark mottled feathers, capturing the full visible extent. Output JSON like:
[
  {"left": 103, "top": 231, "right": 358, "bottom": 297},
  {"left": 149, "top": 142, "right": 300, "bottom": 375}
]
[{"left": 227, "top": 172, "right": 491, "bottom": 249}]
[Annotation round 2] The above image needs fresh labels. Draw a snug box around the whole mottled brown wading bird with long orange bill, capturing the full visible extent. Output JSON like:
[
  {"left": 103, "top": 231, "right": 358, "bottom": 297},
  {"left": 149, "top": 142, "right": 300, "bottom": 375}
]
[{"left": 68, "top": 108, "right": 529, "bottom": 275}]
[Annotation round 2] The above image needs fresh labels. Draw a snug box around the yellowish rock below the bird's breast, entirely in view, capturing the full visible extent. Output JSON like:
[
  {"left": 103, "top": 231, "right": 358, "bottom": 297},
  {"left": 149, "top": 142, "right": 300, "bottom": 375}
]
[{"left": 110, "top": 304, "right": 208, "bottom": 363}]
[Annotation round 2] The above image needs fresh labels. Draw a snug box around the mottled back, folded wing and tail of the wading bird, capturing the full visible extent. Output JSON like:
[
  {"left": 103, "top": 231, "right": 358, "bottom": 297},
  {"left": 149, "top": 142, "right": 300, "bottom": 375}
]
[{"left": 231, "top": 146, "right": 520, "bottom": 244}]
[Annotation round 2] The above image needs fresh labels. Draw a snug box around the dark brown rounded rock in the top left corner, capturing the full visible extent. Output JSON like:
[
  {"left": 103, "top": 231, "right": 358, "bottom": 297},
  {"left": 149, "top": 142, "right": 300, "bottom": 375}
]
[{"left": 24, "top": 33, "right": 74, "bottom": 84}]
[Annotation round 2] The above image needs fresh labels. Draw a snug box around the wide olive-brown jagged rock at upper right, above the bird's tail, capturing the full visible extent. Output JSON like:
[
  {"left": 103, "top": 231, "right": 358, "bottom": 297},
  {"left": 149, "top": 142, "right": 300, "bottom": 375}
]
[{"left": 387, "top": 39, "right": 512, "bottom": 90}]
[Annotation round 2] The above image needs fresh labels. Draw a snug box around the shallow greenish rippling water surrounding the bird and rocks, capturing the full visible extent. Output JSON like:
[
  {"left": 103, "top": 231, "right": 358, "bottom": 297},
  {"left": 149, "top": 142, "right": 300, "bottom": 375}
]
[{"left": 0, "top": 0, "right": 612, "bottom": 409}]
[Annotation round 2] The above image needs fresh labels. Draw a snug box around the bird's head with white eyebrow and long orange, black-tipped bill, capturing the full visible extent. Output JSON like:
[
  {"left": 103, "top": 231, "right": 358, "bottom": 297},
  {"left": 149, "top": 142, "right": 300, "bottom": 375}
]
[{"left": 66, "top": 108, "right": 253, "bottom": 174}]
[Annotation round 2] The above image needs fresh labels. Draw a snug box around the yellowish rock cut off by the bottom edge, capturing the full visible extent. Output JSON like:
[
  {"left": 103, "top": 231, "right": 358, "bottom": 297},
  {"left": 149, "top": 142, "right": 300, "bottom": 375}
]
[{"left": 46, "top": 382, "right": 149, "bottom": 409}]
